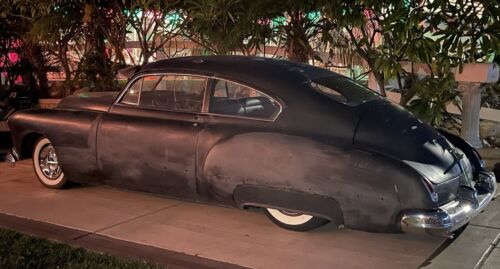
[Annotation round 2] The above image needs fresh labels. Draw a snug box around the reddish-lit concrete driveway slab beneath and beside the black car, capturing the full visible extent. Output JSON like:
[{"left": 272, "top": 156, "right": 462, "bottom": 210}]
[{"left": 0, "top": 160, "right": 443, "bottom": 268}]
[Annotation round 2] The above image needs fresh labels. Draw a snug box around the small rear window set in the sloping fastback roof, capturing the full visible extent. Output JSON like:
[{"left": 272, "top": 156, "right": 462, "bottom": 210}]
[{"left": 311, "top": 76, "right": 381, "bottom": 105}]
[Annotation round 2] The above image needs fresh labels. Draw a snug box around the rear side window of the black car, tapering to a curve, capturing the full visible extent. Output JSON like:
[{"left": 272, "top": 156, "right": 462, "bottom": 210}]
[{"left": 209, "top": 79, "right": 280, "bottom": 119}]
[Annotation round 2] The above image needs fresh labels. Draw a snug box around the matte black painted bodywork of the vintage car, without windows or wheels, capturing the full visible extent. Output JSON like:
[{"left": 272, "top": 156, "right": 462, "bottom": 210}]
[{"left": 9, "top": 56, "right": 484, "bottom": 231}]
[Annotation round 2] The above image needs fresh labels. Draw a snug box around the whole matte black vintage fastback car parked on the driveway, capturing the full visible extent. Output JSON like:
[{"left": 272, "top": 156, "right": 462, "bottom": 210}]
[{"left": 8, "top": 56, "right": 496, "bottom": 236}]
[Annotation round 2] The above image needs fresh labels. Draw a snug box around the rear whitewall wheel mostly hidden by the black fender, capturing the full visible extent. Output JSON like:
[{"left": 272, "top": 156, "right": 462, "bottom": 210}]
[{"left": 265, "top": 208, "right": 328, "bottom": 232}]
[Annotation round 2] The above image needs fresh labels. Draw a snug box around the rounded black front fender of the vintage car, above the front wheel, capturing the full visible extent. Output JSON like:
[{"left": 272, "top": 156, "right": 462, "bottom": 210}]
[{"left": 8, "top": 109, "right": 102, "bottom": 181}]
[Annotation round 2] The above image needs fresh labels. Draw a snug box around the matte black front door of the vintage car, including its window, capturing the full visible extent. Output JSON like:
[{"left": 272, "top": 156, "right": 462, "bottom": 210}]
[{"left": 97, "top": 74, "right": 207, "bottom": 197}]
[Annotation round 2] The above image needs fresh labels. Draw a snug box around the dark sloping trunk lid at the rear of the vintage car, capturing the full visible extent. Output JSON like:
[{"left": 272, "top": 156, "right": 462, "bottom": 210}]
[{"left": 354, "top": 100, "right": 464, "bottom": 184}]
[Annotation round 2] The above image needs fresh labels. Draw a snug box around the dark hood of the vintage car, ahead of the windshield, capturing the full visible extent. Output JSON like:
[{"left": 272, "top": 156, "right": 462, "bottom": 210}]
[{"left": 57, "top": 92, "right": 119, "bottom": 112}]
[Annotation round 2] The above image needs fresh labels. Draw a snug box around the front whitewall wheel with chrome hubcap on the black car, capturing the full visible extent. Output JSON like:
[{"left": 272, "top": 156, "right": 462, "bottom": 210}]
[{"left": 33, "top": 137, "right": 68, "bottom": 189}]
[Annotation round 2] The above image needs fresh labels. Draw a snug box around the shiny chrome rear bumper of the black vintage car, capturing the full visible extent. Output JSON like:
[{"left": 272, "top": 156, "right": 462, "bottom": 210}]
[{"left": 400, "top": 172, "right": 497, "bottom": 237}]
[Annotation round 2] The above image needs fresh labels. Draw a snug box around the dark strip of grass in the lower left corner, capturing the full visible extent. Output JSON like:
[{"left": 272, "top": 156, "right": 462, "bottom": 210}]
[{"left": 0, "top": 229, "right": 162, "bottom": 269}]
